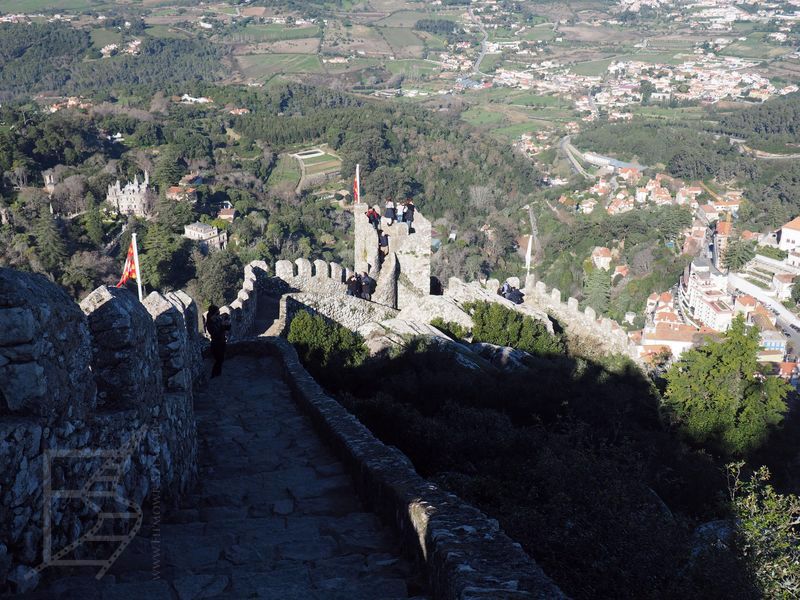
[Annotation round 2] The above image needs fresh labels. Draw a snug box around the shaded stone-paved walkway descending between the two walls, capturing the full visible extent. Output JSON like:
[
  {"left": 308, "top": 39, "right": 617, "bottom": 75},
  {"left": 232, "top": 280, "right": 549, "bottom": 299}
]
[{"left": 25, "top": 357, "right": 423, "bottom": 600}]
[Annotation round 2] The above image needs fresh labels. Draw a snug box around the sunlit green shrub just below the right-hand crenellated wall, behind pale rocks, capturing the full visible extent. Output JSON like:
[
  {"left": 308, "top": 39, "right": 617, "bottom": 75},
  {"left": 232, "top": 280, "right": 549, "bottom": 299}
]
[{"left": 465, "top": 302, "right": 564, "bottom": 356}]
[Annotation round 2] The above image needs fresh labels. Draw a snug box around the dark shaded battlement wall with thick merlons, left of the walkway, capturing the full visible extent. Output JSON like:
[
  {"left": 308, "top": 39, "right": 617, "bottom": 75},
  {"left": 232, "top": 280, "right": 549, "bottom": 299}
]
[{"left": 0, "top": 269, "right": 201, "bottom": 592}]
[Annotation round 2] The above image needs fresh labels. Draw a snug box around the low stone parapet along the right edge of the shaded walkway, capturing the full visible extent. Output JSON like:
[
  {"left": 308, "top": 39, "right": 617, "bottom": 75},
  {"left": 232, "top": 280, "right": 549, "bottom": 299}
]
[{"left": 231, "top": 338, "right": 564, "bottom": 600}]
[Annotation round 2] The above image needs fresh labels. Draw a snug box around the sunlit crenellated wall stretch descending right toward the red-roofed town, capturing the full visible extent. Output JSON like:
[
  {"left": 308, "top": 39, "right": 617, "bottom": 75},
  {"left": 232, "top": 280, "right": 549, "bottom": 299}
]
[{"left": 525, "top": 275, "right": 641, "bottom": 363}]
